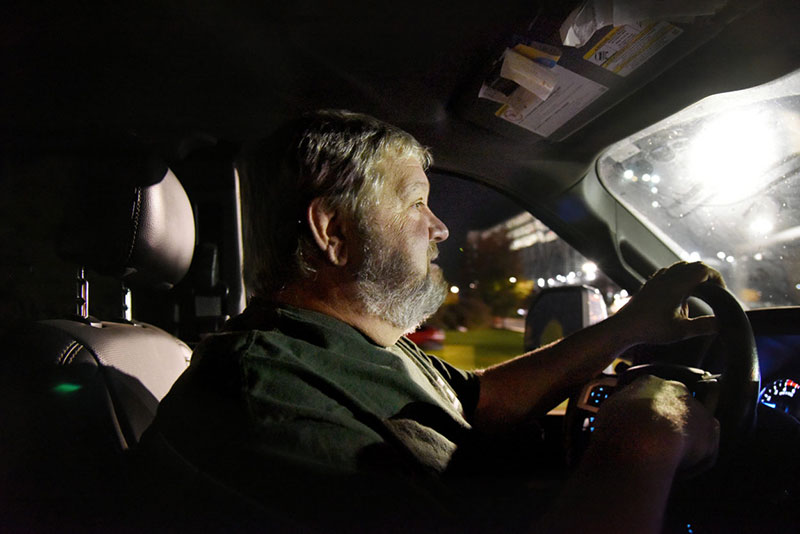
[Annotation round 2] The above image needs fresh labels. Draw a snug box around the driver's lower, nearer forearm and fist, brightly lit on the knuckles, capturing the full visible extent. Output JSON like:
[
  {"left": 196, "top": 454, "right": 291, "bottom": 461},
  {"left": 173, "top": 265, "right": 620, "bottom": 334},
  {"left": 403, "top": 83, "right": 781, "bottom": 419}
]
[{"left": 535, "top": 376, "right": 719, "bottom": 533}]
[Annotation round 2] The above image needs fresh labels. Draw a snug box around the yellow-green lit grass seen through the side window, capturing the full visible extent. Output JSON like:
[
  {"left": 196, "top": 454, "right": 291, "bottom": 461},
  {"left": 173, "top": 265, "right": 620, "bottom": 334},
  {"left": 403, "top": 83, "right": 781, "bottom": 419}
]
[{"left": 428, "top": 328, "right": 522, "bottom": 370}]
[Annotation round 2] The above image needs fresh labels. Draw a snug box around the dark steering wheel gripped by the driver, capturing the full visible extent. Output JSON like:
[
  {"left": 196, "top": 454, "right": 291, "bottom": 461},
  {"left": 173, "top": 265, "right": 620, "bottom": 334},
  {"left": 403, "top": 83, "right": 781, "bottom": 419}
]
[{"left": 565, "top": 283, "right": 761, "bottom": 463}]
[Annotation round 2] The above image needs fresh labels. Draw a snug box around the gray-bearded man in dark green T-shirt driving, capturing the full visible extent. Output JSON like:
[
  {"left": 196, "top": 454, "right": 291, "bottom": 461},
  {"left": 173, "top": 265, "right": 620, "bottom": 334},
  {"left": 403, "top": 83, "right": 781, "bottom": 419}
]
[{"left": 143, "top": 111, "right": 722, "bottom": 532}]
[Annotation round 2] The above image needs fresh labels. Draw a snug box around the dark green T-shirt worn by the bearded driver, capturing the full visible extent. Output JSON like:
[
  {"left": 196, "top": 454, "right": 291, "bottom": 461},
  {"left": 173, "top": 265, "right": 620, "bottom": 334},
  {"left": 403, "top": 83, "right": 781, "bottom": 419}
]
[{"left": 143, "top": 302, "right": 488, "bottom": 532}]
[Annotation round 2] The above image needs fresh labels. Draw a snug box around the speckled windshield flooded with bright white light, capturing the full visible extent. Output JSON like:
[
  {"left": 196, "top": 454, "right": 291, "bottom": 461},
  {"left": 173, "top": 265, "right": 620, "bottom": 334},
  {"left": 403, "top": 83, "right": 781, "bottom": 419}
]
[{"left": 597, "top": 71, "right": 800, "bottom": 308}]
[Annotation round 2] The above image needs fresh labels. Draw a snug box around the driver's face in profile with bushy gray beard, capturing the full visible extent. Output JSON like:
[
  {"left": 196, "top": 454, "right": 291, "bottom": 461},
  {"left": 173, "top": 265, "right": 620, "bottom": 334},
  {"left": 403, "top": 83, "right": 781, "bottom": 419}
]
[{"left": 356, "top": 160, "right": 448, "bottom": 332}]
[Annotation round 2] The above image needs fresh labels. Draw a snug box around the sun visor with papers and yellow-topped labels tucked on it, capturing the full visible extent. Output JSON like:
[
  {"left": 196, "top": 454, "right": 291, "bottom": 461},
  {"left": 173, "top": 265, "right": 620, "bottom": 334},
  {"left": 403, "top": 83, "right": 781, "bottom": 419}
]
[{"left": 454, "top": 0, "right": 738, "bottom": 144}]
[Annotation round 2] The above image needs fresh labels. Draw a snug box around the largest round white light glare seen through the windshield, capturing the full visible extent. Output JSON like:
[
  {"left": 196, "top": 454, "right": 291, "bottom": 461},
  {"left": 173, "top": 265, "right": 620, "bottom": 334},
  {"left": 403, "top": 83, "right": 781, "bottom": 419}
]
[{"left": 689, "top": 110, "right": 779, "bottom": 202}]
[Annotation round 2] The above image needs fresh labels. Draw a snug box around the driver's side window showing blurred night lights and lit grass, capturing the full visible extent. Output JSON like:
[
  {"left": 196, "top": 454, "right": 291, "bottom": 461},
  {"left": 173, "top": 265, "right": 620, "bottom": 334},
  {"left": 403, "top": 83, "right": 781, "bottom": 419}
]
[{"left": 422, "top": 173, "right": 626, "bottom": 369}]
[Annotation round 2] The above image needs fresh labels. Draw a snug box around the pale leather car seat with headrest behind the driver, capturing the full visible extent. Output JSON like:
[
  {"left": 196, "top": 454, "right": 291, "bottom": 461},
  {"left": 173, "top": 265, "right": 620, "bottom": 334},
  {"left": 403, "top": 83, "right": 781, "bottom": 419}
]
[{"left": 0, "top": 160, "right": 195, "bottom": 532}]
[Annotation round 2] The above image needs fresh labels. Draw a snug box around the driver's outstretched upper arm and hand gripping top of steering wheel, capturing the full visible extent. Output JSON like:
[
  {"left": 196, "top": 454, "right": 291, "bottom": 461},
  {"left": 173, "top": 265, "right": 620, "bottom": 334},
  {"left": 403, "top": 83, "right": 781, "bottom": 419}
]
[{"left": 474, "top": 263, "right": 722, "bottom": 431}]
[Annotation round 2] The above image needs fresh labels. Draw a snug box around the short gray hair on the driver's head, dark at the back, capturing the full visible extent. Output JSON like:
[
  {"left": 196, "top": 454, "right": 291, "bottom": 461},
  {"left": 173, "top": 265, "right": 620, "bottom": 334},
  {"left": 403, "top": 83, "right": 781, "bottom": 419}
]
[{"left": 237, "top": 110, "right": 432, "bottom": 298}]
